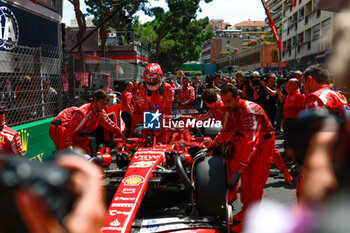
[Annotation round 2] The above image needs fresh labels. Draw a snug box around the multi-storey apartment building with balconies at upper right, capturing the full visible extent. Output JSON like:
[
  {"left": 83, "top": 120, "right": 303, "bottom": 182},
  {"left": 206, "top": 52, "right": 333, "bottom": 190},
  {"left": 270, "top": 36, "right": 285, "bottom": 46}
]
[{"left": 282, "top": 0, "right": 334, "bottom": 70}]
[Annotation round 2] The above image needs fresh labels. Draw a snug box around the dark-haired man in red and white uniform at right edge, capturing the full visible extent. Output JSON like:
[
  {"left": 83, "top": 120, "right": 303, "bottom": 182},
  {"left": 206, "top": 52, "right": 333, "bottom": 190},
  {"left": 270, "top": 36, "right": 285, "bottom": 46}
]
[{"left": 302, "top": 64, "right": 349, "bottom": 117}]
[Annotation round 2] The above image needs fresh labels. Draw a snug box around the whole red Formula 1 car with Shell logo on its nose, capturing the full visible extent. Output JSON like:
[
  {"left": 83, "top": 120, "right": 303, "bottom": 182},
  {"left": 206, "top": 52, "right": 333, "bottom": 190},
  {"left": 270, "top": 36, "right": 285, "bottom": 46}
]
[{"left": 101, "top": 118, "right": 232, "bottom": 233}]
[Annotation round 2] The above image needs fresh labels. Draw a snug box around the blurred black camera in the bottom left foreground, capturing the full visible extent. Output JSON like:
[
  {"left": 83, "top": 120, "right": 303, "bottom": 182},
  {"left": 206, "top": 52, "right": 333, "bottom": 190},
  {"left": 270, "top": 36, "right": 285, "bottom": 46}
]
[{"left": 0, "top": 155, "right": 76, "bottom": 232}]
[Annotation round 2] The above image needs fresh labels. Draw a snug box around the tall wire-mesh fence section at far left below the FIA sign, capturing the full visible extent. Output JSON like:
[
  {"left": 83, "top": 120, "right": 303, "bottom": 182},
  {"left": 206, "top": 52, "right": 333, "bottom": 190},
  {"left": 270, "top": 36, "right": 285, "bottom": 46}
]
[{"left": 0, "top": 46, "right": 63, "bottom": 126}]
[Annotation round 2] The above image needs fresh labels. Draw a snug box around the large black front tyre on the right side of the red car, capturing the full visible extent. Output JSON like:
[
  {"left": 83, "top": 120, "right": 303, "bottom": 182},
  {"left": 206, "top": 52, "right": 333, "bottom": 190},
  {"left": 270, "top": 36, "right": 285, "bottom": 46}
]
[{"left": 194, "top": 156, "right": 227, "bottom": 218}]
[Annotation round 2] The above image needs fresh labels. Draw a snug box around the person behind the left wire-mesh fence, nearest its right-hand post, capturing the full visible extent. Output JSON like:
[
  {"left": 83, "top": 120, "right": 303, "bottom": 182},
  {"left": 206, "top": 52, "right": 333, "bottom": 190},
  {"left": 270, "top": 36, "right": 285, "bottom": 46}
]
[{"left": 43, "top": 80, "right": 58, "bottom": 116}]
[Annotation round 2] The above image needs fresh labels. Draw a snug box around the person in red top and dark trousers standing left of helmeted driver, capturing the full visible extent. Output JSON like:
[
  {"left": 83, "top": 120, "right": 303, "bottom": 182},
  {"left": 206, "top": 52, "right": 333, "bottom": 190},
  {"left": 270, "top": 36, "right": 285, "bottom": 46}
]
[{"left": 120, "top": 82, "right": 134, "bottom": 138}]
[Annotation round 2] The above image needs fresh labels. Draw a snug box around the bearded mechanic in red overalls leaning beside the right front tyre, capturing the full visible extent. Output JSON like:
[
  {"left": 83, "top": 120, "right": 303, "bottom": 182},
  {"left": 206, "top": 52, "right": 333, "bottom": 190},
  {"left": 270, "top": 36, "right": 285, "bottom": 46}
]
[{"left": 208, "top": 85, "right": 275, "bottom": 225}]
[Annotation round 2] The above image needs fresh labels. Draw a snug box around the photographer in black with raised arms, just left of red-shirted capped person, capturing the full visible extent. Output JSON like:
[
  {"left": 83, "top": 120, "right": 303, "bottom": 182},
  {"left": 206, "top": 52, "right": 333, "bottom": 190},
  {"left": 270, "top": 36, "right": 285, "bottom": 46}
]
[{"left": 254, "top": 73, "right": 277, "bottom": 126}]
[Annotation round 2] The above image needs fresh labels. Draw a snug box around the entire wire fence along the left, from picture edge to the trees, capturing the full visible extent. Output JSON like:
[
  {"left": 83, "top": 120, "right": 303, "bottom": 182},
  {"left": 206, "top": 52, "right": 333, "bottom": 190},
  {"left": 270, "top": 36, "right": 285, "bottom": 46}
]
[{"left": 0, "top": 42, "right": 144, "bottom": 126}]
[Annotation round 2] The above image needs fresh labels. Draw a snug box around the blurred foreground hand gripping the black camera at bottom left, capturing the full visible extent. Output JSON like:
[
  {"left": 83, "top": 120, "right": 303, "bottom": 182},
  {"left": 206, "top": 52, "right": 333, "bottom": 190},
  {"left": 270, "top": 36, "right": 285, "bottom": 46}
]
[{"left": 15, "top": 156, "right": 106, "bottom": 233}]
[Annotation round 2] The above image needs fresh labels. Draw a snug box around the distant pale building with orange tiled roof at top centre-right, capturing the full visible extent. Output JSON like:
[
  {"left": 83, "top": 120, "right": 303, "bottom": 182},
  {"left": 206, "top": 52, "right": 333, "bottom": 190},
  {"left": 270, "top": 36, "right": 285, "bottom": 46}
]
[{"left": 235, "top": 20, "right": 269, "bottom": 50}]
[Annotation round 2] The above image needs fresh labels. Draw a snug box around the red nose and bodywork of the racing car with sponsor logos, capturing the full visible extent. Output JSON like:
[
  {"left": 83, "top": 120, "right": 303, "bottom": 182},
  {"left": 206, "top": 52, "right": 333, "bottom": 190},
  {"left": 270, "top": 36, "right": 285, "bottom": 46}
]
[{"left": 101, "top": 129, "right": 219, "bottom": 233}]
